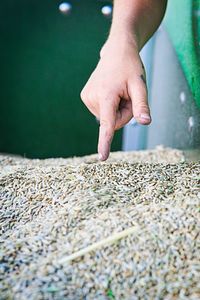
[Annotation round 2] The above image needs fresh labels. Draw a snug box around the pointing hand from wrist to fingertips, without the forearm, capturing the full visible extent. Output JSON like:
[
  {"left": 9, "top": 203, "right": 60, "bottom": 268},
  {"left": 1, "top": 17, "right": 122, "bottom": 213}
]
[{"left": 81, "top": 38, "right": 151, "bottom": 160}]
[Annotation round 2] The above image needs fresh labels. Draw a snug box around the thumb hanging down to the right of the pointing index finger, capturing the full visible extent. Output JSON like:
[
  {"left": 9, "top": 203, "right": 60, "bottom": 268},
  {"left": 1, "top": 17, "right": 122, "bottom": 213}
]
[{"left": 129, "top": 75, "right": 151, "bottom": 125}]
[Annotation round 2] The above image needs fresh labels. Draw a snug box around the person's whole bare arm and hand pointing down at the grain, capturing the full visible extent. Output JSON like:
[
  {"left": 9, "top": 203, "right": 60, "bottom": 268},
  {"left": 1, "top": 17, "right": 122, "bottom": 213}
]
[{"left": 81, "top": 0, "right": 166, "bottom": 161}]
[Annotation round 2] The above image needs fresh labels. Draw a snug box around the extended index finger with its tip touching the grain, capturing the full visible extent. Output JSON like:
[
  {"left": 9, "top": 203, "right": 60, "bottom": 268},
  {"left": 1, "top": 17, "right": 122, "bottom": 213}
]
[{"left": 98, "top": 99, "right": 117, "bottom": 161}]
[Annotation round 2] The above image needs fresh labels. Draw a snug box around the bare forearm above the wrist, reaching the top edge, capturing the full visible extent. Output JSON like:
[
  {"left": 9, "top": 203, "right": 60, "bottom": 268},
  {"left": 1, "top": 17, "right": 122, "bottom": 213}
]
[{"left": 109, "top": 0, "right": 167, "bottom": 50}]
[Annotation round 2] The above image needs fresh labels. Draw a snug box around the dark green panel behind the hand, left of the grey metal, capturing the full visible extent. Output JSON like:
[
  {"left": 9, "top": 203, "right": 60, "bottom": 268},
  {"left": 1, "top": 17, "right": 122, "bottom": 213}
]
[{"left": 0, "top": 0, "right": 121, "bottom": 158}]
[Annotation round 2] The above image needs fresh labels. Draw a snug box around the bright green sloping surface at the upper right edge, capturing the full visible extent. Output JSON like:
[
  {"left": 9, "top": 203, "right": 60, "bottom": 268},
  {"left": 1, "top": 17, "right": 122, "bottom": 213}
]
[{"left": 164, "top": 0, "right": 200, "bottom": 108}]
